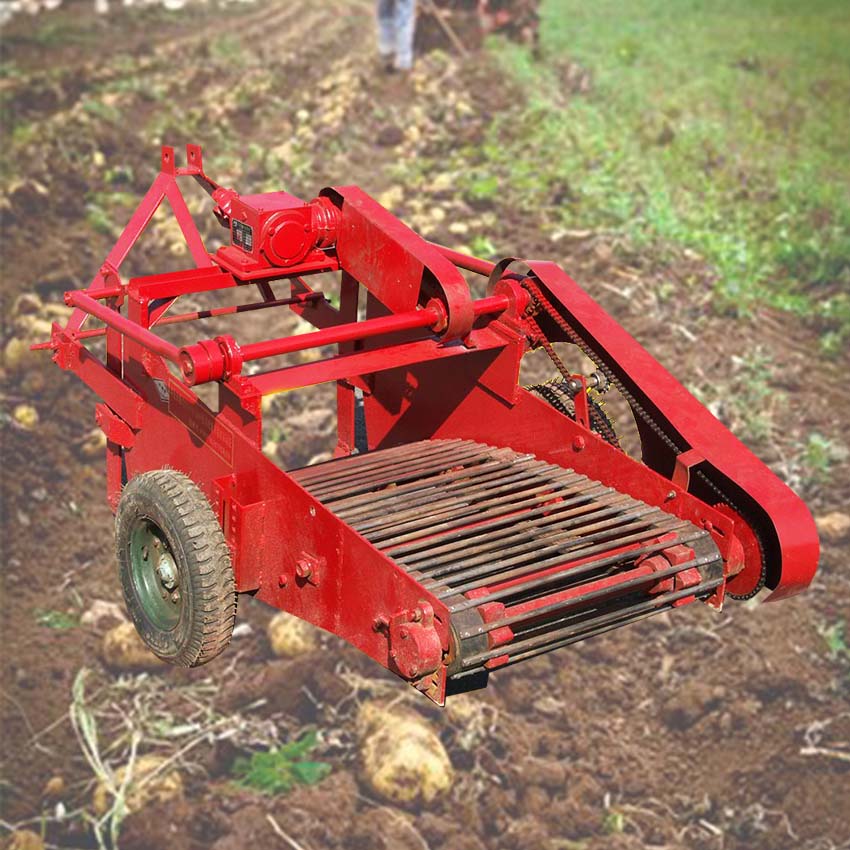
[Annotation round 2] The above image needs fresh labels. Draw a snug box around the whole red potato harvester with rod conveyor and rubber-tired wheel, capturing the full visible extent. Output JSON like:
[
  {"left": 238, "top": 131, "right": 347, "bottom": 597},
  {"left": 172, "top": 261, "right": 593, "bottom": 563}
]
[{"left": 40, "top": 145, "right": 818, "bottom": 704}]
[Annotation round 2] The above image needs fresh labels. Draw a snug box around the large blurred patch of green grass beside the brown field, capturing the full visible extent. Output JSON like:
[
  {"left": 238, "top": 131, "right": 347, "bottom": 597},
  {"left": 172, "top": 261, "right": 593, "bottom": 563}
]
[{"left": 465, "top": 0, "right": 850, "bottom": 352}]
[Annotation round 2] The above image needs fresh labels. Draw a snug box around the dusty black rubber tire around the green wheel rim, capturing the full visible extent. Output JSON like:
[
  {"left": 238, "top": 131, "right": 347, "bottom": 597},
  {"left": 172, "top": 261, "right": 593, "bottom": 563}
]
[{"left": 115, "top": 469, "right": 236, "bottom": 667}]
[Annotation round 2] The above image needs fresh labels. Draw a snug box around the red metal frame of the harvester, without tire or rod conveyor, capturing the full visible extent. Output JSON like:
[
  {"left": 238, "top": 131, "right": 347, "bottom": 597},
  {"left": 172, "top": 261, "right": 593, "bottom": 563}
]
[{"left": 42, "top": 145, "right": 818, "bottom": 702}]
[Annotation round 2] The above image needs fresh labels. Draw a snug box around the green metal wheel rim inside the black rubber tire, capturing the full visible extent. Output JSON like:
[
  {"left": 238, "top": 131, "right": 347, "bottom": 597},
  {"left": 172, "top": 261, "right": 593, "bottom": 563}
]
[{"left": 130, "top": 519, "right": 183, "bottom": 631}]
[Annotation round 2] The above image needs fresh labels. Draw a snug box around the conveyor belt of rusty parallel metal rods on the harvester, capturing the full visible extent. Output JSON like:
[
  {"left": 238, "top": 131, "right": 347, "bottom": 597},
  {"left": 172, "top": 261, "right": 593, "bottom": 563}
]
[{"left": 292, "top": 440, "right": 723, "bottom": 676}]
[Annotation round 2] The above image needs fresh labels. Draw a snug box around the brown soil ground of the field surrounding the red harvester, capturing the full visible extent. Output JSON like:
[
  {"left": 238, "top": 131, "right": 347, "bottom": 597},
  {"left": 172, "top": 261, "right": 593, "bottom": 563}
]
[{"left": 0, "top": 0, "right": 850, "bottom": 850}]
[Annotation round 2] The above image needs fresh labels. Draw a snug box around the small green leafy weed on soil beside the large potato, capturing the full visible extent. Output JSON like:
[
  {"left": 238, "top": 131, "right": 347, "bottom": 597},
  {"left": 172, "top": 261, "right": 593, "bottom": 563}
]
[{"left": 231, "top": 732, "right": 331, "bottom": 795}]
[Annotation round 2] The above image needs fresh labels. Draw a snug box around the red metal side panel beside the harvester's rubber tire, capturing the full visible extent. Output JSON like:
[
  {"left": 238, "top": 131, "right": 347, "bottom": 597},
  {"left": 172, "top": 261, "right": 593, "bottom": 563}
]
[{"left": 70, "top": 332, "right": 449, "bottom": 684}]
